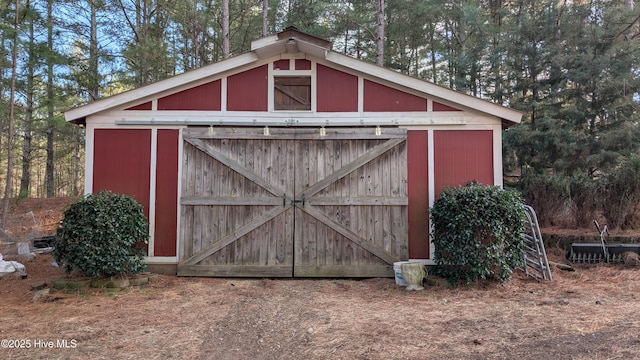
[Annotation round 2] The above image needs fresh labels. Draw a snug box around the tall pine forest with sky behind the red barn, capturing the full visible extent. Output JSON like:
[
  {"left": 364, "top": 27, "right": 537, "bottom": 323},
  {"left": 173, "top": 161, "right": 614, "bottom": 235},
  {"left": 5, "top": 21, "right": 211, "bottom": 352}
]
[{"left": 0, "top": 0, "right": 640, "bottom": 229}]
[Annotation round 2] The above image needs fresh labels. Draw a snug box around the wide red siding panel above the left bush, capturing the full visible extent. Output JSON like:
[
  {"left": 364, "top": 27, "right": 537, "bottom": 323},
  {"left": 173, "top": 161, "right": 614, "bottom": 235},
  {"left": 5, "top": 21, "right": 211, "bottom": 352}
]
[{"left": 93, "top": 129, "right": 151, "bottom": 252}]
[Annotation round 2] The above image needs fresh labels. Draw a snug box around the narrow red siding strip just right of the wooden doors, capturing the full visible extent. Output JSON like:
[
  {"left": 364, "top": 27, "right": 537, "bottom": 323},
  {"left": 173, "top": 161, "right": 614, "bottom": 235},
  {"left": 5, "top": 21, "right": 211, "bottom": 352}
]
[{"left": 407, "top": 130, "right": 429, "bottom": 259}]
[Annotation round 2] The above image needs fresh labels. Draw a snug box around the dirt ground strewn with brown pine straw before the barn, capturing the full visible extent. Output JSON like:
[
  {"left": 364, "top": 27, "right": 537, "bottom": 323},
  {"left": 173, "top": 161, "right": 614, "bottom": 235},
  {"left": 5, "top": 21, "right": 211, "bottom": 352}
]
[{"left": 0, "top": 199, "right": 640, "bottom": 360}]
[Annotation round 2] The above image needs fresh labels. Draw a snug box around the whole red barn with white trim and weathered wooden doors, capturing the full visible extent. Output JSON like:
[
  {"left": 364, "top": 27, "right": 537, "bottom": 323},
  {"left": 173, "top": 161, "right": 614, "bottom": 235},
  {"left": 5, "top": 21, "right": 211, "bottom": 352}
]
[{"left": 65, "top": 29, "right": 521, "bottom": 277}]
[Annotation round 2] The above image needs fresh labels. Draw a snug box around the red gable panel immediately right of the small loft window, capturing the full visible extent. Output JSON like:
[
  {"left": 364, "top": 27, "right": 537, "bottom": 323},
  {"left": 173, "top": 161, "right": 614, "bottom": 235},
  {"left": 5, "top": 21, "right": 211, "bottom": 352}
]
[{"left": 316, "top": 65, "right": 358, "bottom": 112}]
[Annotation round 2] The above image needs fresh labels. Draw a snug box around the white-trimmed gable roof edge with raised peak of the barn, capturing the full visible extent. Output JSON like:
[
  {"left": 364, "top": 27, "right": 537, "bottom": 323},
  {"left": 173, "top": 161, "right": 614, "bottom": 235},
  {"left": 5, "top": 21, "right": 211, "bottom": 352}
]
[{"left": 65, "top": 27, "right": 522, "bottom": 126}]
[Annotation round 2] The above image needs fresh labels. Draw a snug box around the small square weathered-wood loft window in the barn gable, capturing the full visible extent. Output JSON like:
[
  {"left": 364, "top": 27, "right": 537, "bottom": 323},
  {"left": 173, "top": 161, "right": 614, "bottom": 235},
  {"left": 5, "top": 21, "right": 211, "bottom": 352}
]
[{"left": 273, "top": 76, "right": 311, "bottom": 110}]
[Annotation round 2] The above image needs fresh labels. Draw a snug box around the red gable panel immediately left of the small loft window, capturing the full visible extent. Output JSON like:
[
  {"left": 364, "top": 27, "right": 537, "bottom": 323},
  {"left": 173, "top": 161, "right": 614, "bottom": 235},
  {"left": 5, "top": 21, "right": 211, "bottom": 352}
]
[{"left": 227, "top": 65, "right": 268, "bottom": 111}]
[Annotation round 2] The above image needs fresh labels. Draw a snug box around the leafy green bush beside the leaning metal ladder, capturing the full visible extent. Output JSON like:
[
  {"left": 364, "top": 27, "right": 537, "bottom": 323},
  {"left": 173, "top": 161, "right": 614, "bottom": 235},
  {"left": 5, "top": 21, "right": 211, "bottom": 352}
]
[{"left": 430, "top": 183, "right": 524, "bottom": 283}]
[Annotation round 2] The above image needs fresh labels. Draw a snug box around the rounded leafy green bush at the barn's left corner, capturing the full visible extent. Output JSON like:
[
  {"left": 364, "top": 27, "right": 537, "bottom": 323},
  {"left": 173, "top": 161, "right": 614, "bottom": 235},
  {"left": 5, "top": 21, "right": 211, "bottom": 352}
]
[{"left": 54, "top": 191, "right": 149, "bottom": 277}]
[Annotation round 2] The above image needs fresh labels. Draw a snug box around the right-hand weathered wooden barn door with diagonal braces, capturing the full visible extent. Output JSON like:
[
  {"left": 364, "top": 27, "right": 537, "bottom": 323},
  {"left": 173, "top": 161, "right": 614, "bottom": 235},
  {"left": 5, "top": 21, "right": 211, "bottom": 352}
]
[{"left": 294, "top": 129, "right": 408, "bottom": 277}]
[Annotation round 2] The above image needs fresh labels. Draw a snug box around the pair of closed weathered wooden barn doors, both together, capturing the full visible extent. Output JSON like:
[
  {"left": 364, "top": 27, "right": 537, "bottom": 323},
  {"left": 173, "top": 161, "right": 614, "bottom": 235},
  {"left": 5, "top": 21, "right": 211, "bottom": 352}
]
[{"left": 178, "top": 128, "right": 407, "bottom": 277}]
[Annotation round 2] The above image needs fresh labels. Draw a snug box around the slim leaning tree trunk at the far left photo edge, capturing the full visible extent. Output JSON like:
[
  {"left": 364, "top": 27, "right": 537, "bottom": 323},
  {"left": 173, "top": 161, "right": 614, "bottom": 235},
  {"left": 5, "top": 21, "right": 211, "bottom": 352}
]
[{"left": 2, "top": 0, "right": 20, "bottom": 228}]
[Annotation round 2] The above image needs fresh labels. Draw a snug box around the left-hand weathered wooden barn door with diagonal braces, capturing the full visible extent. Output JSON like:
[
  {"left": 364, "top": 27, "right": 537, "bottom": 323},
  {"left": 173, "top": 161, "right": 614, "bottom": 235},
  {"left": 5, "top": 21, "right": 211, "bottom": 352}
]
[{"left": 178, "top": 128, "right": 294, "bottom": 277}]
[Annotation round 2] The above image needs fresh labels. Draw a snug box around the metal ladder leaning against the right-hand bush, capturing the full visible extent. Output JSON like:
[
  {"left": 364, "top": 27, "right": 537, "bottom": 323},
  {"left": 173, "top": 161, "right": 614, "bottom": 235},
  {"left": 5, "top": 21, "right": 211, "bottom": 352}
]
[{"left": 522, "top": 205, "right": 553, "bottom": 280}]
